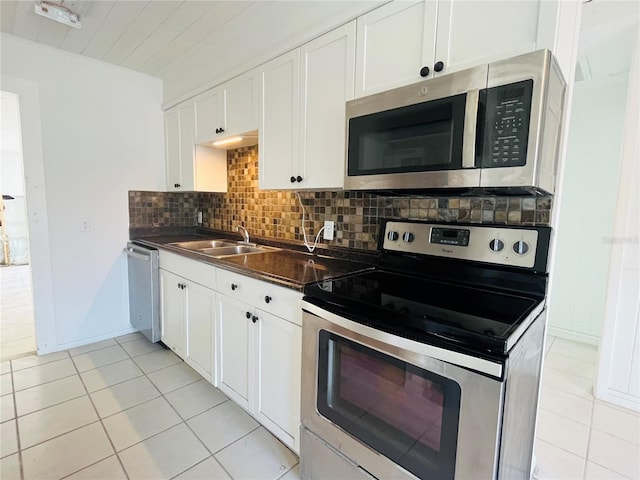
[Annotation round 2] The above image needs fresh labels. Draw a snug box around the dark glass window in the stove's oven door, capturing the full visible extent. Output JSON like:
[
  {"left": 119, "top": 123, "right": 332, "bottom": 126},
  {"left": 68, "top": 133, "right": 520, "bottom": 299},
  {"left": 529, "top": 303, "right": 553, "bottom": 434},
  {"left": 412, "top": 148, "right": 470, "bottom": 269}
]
[{"left": 317, "top": 330, "right": 460, "bottom": 479}]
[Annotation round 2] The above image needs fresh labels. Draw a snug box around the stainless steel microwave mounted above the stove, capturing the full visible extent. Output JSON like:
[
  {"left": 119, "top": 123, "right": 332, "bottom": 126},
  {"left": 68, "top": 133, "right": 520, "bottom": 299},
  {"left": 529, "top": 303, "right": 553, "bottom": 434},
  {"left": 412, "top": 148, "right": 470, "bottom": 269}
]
[{"left": 345, "top": 50, "right": 565, "bottom": 194}]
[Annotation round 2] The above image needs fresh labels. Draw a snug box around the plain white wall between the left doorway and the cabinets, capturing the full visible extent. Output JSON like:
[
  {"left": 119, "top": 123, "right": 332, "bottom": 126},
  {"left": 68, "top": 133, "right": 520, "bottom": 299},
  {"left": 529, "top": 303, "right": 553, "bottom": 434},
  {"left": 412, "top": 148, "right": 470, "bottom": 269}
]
[{"left": 0, "top": 34, "right": 164, "bottom": 353}]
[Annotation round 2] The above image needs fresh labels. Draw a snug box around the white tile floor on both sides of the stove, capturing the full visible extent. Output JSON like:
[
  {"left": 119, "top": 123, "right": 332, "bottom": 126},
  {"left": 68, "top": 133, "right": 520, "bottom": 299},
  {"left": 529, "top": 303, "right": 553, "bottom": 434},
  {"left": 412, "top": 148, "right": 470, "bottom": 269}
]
[{"left": 0, "top": 326, "right": 640, "bottom": 480}]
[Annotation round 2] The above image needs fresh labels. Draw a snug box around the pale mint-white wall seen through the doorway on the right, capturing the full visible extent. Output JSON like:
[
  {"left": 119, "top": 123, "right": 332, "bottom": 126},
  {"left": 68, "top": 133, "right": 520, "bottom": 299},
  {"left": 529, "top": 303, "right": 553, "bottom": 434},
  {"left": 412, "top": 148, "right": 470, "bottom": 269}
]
[{"left": 549, "top": 75, "right": 627, "bottom": 344}]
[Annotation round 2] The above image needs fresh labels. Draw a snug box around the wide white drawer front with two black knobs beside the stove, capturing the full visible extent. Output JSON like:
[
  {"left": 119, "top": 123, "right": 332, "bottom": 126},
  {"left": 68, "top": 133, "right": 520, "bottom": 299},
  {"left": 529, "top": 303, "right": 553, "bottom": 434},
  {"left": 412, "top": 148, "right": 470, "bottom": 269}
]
[{"left": 217, "top": 269, "right": 302, "bottom": 325}]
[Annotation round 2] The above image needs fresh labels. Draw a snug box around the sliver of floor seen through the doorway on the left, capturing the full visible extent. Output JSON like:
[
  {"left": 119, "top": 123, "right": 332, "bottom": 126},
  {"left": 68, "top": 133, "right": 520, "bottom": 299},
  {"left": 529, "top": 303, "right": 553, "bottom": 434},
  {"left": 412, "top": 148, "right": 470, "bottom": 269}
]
[{"left": 0, "top": 265, "right": 36, "bottom": 362}]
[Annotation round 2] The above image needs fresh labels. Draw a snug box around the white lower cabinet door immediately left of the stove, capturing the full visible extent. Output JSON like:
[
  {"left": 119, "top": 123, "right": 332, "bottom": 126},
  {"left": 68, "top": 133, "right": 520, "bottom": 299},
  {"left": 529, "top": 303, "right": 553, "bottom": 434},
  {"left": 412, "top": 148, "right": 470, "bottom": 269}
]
[{"left": 255, "top": 310, "right": 302, "bottom": 452}]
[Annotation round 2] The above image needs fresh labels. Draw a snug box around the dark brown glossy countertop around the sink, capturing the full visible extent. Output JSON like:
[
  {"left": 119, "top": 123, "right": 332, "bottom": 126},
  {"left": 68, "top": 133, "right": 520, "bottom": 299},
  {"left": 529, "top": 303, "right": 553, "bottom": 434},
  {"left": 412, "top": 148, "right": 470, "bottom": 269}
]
[{"left": 135, "top": 232, "right": 375, "bottom": 291}]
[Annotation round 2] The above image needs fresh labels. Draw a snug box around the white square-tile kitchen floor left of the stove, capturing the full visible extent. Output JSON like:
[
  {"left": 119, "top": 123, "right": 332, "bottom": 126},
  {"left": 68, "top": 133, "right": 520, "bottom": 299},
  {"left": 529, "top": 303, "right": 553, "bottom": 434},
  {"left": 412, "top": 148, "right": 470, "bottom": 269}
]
[{"left": 0, "top": 334, "right": 299, "bottom": 480}]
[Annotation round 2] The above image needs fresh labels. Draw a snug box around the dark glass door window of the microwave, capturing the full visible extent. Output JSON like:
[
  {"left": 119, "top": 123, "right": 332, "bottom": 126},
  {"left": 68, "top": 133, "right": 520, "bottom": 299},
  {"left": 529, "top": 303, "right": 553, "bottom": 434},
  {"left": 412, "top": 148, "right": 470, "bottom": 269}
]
[{"left": 348, "top": 94, "right": 466, "bottom": 176}]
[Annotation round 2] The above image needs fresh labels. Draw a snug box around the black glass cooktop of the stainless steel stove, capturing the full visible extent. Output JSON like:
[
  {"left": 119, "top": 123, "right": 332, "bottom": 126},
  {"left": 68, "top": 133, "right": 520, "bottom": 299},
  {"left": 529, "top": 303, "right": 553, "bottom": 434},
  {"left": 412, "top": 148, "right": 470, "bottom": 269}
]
[{"left": 304, "top": 270, "right": 543, "bottom": 354}]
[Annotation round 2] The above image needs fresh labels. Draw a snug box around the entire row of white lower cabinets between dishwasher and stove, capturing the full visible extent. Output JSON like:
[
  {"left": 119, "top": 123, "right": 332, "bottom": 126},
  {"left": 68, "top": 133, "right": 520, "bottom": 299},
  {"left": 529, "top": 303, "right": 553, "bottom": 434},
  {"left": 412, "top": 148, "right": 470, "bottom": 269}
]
[{"left": 160, "top": 251, "right": 302, "bottom": 452}]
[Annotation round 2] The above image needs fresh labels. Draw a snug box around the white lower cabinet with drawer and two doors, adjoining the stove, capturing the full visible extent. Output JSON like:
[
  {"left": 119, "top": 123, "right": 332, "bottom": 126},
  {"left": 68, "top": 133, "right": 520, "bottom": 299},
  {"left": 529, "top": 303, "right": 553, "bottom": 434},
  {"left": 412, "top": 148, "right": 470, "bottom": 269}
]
[{"left": 216, "top": 269, "right": 302, "bottom": 452}]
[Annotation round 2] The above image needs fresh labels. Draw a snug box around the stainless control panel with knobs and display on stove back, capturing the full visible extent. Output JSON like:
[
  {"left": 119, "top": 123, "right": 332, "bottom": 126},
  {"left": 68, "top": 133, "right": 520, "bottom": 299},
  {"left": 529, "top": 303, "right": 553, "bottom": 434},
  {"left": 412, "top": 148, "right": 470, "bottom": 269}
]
[{"left": 383, "top": 221, "right": 538, "bottom": 268}]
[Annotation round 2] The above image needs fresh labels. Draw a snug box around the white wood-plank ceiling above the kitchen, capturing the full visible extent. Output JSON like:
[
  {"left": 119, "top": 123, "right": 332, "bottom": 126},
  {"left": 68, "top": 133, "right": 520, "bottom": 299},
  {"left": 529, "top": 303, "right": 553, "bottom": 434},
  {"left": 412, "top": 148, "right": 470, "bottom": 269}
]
[{"left": 0, "top": 0, "right": 381, "bottom": 88}]
